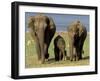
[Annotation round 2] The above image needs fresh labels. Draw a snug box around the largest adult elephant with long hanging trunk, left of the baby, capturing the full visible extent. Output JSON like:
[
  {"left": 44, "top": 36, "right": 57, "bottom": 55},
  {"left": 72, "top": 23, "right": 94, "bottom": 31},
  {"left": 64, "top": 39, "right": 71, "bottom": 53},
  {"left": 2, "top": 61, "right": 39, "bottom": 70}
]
[{"left": 28, "top": 14, "right": 56, "bottom": 63}]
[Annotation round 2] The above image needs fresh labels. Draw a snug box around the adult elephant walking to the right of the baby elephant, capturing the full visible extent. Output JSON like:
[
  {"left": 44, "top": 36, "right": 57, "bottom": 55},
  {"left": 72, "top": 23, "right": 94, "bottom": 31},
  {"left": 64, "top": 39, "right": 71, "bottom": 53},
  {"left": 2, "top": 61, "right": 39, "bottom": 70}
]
[{"left": 68, "top": 21, "right": 87, "bottom": 61}]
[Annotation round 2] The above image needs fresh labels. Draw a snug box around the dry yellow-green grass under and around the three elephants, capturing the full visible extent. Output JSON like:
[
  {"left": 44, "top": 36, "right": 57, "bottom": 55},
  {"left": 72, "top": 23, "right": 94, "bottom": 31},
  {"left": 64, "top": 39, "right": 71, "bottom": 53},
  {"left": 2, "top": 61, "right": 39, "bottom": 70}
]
[{"left": 25, "top": 32, "right": 89, "bottom": 68}]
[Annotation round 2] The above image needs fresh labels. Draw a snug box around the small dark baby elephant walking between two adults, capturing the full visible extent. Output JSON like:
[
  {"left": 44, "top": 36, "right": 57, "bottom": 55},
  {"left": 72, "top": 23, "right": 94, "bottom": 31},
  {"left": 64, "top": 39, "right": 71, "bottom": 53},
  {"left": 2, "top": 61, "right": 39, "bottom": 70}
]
[{"left": 54, "top": 35, "right": 67, "bottom": 61}]
